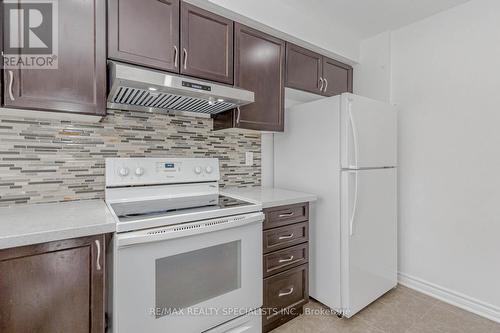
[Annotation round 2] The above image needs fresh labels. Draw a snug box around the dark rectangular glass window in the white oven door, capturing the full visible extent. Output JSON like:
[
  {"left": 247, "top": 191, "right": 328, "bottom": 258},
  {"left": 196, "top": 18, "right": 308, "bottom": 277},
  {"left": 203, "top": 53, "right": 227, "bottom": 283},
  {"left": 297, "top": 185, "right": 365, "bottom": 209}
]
[{"left": 156, "top": 241, "right": 241, "bottom": 318}]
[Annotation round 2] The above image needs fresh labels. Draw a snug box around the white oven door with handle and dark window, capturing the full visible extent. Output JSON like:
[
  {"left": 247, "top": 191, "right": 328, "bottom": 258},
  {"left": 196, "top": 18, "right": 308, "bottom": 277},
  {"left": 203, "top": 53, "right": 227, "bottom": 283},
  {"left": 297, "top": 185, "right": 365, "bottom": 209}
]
[{"left": 113, "top": 213, "right": 264, "bottom": 333}]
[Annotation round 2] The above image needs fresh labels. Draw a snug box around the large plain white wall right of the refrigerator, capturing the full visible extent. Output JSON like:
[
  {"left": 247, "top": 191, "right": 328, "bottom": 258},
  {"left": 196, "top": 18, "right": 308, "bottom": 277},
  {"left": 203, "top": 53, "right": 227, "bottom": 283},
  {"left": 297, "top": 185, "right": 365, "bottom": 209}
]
[{"left": 392, "top": 0, "right": 500, "bottom": 320}]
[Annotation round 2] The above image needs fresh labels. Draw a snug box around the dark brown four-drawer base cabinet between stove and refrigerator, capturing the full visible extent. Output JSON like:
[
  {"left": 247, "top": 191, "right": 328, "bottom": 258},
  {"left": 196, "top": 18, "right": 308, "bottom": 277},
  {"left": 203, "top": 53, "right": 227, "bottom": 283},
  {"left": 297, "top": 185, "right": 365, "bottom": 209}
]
[{"left": 262, "top": 203, "right": 309, "bottom": 333}]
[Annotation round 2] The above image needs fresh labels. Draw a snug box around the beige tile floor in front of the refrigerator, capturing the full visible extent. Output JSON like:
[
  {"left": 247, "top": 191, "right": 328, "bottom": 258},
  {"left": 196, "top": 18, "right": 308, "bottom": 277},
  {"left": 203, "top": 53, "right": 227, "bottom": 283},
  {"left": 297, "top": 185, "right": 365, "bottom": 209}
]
[{"left": 272, "top": 286, "right": 500, "bottom": 333}]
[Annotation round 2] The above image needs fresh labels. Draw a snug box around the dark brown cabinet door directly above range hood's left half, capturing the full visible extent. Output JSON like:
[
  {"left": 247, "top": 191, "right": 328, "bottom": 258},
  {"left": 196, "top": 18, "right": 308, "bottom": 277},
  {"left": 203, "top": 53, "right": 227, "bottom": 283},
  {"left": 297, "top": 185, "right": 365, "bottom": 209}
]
[{"left": 108, "top": 0, "right": 180, "bottom": 72}]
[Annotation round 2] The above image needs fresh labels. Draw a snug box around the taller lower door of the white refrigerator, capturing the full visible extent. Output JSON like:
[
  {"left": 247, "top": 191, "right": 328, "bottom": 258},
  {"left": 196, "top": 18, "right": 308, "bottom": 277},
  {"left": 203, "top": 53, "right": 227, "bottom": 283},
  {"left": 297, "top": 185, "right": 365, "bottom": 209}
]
[{"left": 341, "top": 168, "right": 397, "bottom": 317}]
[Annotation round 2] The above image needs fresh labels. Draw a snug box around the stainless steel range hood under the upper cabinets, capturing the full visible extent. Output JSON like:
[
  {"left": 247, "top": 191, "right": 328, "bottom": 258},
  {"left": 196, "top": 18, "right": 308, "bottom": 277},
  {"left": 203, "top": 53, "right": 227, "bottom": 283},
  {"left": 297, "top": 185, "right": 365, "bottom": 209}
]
[{"left": 108, "top": 61, "right": 254, "bottom": 117}]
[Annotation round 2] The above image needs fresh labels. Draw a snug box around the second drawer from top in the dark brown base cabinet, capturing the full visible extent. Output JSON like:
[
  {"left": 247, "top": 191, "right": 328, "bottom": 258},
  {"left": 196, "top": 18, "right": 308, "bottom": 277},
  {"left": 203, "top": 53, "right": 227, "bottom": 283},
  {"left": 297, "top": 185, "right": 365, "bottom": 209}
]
[{"left": 263, "top": 222, "right": 309, "bottom": 253}]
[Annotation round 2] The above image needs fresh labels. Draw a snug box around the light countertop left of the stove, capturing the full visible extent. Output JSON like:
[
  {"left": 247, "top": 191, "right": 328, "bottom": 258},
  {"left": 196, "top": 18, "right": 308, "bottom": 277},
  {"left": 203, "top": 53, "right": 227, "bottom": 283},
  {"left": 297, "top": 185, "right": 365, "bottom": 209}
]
[{"left": 0, "top": 200, "right": 116, "bottom": 249}]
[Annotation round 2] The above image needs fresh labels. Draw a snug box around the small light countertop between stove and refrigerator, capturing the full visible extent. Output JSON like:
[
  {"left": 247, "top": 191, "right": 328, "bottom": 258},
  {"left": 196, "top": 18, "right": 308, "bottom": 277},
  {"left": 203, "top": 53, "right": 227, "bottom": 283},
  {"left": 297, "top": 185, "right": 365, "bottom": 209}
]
[{"left": 220, "top": 187, "right": 317, "bottom": 208}]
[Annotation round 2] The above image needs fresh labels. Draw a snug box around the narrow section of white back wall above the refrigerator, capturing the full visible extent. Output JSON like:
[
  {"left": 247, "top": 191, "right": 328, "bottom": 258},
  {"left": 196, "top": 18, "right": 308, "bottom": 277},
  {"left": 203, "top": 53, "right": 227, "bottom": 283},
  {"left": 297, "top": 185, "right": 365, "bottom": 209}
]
[{"left": 353, "top": 32, "right": 391, "bottom": 102}]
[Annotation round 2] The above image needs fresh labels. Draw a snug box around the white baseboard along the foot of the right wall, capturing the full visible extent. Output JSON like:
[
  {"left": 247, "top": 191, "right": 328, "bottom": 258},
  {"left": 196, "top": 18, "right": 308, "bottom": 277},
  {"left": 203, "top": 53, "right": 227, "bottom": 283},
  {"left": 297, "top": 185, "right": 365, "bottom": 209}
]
[{"left": 398, "top": 272, "right": 500, "bottom": 323}]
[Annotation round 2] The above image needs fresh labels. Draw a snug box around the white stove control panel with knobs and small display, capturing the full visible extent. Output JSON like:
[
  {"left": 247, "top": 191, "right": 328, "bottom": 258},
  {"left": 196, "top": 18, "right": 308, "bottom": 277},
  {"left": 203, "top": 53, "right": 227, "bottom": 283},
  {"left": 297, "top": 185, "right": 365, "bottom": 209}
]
[{"left": 106, "top": 157, "right": 220, "bottom": 187}]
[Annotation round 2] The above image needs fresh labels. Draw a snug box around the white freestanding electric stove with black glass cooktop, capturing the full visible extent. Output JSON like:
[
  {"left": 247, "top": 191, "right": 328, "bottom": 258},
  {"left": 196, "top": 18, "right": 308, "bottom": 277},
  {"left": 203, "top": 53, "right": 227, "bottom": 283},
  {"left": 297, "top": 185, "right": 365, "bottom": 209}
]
[{"left": 106, "top": 158, "right": 264, "bottom": 333}]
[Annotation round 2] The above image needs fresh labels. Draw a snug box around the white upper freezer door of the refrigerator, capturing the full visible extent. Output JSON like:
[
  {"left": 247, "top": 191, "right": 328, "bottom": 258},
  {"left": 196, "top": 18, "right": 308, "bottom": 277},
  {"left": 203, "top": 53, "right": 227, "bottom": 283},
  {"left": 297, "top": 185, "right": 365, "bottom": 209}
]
[{"left": 340, "top": 94, "right": 397, "bottom": 169}]
